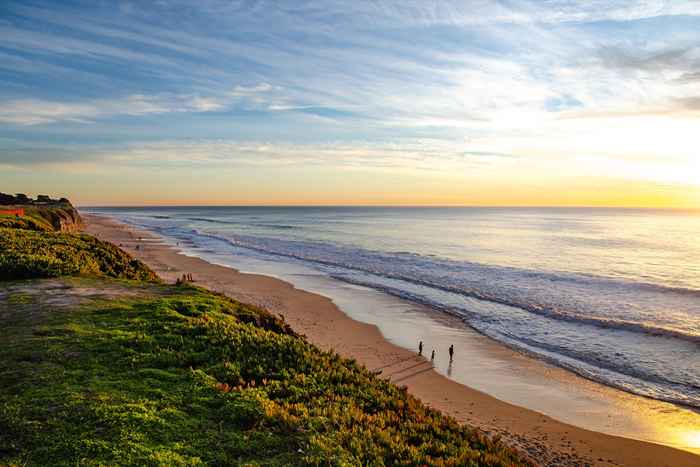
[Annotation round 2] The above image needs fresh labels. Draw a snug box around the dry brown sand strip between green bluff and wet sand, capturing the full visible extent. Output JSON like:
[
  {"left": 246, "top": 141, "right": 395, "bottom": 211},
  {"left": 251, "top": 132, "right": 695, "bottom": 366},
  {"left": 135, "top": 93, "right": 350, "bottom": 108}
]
[{"left": 84, "top": 214, "right": 700, "bottom": 466}]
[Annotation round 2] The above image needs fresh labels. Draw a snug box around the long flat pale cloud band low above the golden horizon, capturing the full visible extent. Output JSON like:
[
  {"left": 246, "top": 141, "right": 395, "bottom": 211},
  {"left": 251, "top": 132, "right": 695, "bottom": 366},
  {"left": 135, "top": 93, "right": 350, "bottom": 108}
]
[{"left": 0, "top": 139, "right": 515, "bottom": 170}]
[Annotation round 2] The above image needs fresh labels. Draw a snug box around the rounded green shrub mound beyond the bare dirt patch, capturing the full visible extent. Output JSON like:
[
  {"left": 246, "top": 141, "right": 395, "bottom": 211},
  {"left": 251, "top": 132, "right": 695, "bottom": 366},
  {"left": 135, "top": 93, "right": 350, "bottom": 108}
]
[{"left": 0, "top": 228, "right": 157, "bottom": 281}]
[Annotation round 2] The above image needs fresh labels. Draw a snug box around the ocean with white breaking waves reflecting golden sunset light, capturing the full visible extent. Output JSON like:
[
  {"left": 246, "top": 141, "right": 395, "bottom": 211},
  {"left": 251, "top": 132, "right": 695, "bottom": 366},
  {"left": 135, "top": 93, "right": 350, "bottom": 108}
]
[{"left": 83, "top": 207, "right": 700, "bottom": 409}]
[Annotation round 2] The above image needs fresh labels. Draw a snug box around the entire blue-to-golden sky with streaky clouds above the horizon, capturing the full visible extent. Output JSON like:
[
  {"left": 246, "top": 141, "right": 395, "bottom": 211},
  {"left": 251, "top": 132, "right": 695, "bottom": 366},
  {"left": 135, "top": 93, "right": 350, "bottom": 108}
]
[{"left": 0, "top": 0, "right": 700, "bottom": 208}]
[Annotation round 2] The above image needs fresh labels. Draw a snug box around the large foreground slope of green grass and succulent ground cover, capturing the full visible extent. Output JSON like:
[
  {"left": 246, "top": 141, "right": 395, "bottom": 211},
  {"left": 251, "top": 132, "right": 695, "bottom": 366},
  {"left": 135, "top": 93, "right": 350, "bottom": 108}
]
[{"left": 0, "top": 280, "right": 528, "bottom": 466}]
